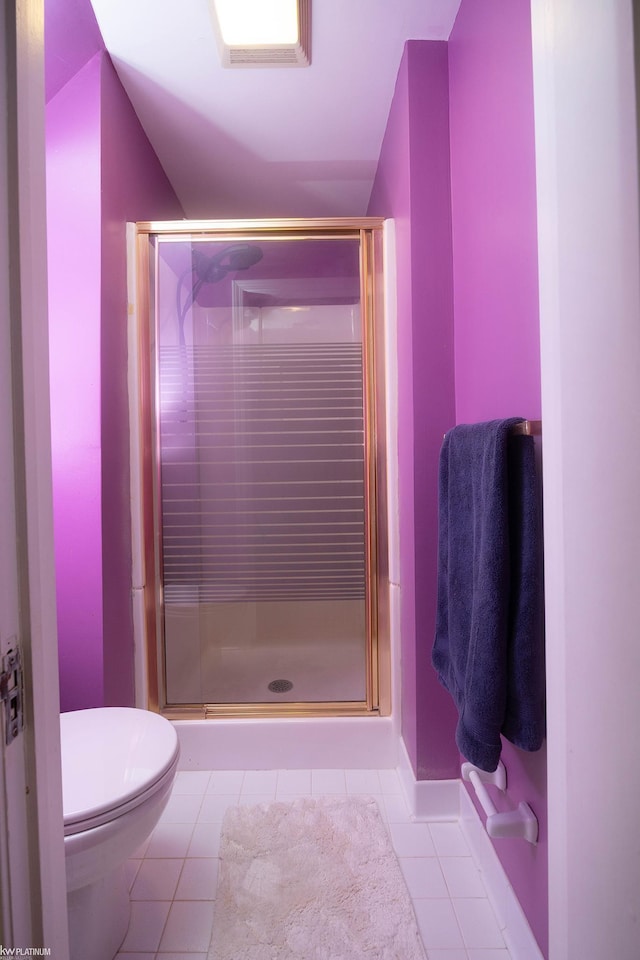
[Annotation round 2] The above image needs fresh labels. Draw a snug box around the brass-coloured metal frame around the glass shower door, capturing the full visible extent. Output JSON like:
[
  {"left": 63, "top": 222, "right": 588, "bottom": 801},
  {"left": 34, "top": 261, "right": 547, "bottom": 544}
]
[{"left": 135, "top": 217, "right": 391, "bottom": 720}]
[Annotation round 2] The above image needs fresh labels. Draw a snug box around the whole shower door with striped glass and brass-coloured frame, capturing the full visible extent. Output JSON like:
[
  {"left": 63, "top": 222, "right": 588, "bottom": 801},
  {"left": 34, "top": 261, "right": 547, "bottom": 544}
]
[{"left": 136, "top": 218, "right": 389, "bottom": 717}]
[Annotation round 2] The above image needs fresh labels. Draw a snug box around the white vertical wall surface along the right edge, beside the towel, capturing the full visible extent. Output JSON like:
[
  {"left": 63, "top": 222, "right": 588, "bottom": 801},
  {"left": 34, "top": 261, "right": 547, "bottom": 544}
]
[{"left": 532, "top": 0, "right": 640, "bottom": 960}]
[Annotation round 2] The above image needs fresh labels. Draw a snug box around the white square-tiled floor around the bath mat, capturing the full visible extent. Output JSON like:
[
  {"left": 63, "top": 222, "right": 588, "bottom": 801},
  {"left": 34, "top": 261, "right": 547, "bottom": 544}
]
[{"left": 118, "top": 770, "right": 511, "bottom": 960}]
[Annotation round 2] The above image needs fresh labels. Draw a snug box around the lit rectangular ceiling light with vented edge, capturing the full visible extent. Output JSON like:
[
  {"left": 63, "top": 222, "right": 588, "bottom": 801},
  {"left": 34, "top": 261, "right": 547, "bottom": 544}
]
[{"left": 211, "top": 0, "right": 311, "bottom": 67}]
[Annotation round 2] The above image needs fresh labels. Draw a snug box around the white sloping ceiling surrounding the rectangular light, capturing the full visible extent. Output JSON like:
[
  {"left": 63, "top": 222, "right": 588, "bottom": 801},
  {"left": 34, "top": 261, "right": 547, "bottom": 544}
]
[{"left": 91, "top": 0, "right": 460, "bottom": 218}]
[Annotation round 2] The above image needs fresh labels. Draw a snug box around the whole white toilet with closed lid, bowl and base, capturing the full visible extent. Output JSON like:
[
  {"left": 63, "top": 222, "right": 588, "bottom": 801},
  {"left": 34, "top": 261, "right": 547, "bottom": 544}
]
[{"left": 60, "top": 707, "right": 179, "bottom": 960}]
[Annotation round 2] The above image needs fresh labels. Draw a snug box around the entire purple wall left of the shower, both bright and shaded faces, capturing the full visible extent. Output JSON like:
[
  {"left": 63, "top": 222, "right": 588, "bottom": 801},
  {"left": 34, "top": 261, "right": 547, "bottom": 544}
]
[{"left": 46, "top": 0, "right": 183, "bottom": 710}]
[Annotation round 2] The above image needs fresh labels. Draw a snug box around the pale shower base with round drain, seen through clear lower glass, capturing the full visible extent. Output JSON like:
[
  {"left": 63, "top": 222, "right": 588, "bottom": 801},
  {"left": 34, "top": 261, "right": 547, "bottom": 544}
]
[{"left": 165, "top": 601, "right": 366, "bottom": 705}]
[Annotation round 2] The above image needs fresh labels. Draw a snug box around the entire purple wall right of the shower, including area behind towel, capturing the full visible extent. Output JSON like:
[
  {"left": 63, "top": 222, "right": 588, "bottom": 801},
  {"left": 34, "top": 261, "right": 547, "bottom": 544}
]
[{"left": 369, "top": 0, "right": 548, "bottom": 951}]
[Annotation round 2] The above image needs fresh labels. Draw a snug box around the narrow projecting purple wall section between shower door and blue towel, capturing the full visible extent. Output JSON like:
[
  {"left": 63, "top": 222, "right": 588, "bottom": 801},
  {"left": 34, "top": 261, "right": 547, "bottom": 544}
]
[{"left": 368, "top": 41, "right": 459, "bottom": 779}]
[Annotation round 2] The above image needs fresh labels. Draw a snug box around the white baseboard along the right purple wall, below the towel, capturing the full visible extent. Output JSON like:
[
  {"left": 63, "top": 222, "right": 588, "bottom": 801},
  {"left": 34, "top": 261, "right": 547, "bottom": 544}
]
[{"left": 398, "top": 740, "right": 544, "bottom": 960}]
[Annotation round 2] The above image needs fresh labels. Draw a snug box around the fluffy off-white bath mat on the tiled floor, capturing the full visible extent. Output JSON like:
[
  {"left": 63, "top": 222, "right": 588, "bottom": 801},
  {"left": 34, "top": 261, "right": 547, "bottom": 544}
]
[{"left": 209, "top": 797, "right": 425, "bottom": 960}]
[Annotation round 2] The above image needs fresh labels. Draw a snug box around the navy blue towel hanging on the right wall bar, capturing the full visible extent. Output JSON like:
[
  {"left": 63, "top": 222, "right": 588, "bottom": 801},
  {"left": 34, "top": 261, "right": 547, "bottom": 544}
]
[{"left": 432, "top": 417, "right": 545, "bottom": 771}]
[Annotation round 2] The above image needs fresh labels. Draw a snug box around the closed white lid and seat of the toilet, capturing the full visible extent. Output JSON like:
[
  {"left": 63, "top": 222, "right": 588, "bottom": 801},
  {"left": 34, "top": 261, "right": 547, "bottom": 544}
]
[{"left": 60, "top": 707, "right": 179, "bottom": 834}]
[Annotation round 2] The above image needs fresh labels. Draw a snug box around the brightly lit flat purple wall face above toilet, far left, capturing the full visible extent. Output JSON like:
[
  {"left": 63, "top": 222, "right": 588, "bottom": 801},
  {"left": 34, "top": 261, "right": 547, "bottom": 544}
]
[{"left": 46, "top": 55, "right": 102, "bottom": 710}]
